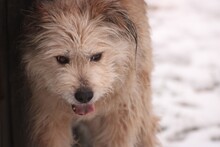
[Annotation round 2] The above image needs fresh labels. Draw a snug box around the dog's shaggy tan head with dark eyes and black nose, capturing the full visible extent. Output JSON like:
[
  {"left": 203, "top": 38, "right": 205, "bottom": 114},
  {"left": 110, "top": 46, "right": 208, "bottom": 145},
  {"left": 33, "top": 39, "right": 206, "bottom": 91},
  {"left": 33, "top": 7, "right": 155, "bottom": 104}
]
[{"left": 23, "top": 0, "right": 136, "bottom": 114}]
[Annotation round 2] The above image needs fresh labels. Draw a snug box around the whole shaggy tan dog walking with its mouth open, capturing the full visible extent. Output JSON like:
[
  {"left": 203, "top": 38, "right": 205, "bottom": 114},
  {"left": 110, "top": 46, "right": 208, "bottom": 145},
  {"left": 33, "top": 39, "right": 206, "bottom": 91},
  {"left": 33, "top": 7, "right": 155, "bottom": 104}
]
[{"left": 22, "top": 0, "right": 157, "bottom": 147}]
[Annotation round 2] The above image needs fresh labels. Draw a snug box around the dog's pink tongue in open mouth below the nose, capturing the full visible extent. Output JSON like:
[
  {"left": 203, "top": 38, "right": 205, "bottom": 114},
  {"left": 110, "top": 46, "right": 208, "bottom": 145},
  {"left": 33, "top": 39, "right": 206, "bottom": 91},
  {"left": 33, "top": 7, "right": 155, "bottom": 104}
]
[{"left": 72, "top": 104, "right": 95, "bottom": 115}]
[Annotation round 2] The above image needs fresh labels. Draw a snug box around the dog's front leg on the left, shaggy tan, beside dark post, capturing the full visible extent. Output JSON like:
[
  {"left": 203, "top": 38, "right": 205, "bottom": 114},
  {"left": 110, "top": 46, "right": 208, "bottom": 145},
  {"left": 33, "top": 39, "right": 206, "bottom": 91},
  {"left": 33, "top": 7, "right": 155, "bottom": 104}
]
[{"left": 29, "top": 92, "right": 76, "bottom": 147}]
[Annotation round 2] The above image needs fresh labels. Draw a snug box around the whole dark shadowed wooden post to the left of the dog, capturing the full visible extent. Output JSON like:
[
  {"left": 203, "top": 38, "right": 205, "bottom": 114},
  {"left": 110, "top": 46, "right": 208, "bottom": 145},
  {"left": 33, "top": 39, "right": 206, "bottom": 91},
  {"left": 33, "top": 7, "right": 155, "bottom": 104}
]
[{"left": 0, "top": 0, "right": 31, "bottom": 147}]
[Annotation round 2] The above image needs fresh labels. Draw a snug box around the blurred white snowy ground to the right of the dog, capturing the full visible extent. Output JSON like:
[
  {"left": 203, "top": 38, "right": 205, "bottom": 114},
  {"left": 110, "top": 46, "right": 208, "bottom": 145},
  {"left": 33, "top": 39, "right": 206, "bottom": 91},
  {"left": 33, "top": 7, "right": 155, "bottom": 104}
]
[{"left": 146, "top": 0, "right": 220, "bottom": 147}]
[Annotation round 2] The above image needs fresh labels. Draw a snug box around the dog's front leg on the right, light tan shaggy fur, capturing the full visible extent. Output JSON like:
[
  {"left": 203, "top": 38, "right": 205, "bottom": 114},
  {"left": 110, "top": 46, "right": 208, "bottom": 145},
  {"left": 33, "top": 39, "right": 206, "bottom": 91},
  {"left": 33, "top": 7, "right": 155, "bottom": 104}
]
[{"left": 90, "top": 110, "right": 138, "bottom": 147}]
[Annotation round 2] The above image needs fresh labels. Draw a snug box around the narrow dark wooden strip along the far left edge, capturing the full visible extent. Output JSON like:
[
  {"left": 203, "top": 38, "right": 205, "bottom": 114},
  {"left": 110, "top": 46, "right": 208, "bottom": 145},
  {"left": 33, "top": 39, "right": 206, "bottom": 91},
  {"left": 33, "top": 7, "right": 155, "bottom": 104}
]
[{"left": 0, "top": 0, "right": 11, "bottom": 147}]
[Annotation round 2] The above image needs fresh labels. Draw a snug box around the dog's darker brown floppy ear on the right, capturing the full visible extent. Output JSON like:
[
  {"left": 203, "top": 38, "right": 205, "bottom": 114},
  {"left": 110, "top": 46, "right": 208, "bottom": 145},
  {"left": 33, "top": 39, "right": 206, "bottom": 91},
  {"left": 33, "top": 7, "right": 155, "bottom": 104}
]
[{"left": 89, "top": 0, "right": 137, "bottom": 45}]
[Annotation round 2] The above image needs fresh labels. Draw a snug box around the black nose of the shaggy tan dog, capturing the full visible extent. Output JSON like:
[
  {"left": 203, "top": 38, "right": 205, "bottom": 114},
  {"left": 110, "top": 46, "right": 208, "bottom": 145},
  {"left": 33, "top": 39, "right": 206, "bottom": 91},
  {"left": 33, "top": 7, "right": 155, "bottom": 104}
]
[{"left": 75, "top": 88, "right": 93, "bottom": 103}]
